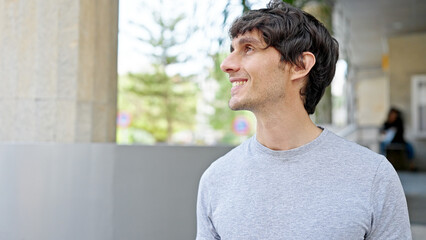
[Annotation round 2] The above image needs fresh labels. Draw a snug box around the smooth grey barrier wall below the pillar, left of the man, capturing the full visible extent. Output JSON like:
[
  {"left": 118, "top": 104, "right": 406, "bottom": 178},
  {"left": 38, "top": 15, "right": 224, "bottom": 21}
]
[{"left": 0, "top": 144, "right": 231, "bottom": 240}]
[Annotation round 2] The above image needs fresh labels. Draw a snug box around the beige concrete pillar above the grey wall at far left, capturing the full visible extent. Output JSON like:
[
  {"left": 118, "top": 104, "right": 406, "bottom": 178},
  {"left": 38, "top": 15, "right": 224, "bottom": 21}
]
[{"left": 0, "top": 0, "right": 118, "bottom": 142}]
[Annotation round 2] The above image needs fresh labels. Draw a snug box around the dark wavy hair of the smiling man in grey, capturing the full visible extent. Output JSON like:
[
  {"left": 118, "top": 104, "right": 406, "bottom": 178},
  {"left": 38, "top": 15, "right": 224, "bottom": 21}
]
[{"left": 229, "top": 0, "right": 339, "bottom": 114}]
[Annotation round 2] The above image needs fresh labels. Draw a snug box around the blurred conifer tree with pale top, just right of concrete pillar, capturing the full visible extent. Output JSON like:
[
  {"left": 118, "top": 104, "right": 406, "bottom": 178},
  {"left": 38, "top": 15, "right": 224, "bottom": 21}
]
[{"left": 120, "top": 7, "right": 198, "bottom": 143}]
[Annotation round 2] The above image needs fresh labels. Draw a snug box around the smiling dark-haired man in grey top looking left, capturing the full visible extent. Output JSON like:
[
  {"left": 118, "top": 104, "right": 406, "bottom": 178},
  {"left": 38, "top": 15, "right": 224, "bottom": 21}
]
[{"left": 197, "top": 1, "right": 411, "bottom": 240}]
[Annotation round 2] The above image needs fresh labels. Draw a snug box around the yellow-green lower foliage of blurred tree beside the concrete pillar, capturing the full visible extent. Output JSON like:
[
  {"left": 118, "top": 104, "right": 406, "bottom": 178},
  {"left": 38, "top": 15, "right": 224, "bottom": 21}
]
[{"left": 120, "top": 71, "right": 198, "bottom": 142}]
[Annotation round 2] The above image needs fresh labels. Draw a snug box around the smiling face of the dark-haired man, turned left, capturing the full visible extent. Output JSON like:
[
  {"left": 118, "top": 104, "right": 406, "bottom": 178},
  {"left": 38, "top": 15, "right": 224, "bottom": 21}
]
[{"left": 220, "top": 30, "right": 288, "bottom": 112}]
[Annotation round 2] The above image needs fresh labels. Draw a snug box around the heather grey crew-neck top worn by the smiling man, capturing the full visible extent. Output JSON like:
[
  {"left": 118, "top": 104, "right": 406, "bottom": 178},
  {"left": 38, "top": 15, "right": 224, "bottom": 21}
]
[{"left": 197, "top": 129, "right": 411, "bottom": 240}]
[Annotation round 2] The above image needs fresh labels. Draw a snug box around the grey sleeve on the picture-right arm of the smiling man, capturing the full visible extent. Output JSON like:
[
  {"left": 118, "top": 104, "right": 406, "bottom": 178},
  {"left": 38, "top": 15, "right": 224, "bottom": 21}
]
[{"left": 366, "top": 157, "right": 411, "bottom": 240}]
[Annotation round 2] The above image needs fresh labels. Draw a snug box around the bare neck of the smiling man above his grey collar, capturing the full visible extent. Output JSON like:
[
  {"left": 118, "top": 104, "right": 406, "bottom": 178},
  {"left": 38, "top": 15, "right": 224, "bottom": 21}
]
[{"left": 255, "top": 106, "right": 322, "bottom": 150}]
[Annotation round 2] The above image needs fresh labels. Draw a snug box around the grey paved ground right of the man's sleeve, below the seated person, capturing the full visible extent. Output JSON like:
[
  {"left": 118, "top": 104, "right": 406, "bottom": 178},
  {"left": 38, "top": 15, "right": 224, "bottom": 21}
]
[{"left": 398, "top": 172, "right": 426, "bottom": 240}]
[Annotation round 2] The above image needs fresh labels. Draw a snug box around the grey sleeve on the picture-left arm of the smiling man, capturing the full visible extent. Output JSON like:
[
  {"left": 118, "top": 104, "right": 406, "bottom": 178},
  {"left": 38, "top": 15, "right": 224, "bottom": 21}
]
[{"left": 196, "top": 170, "right": 220, "bottom": 240}]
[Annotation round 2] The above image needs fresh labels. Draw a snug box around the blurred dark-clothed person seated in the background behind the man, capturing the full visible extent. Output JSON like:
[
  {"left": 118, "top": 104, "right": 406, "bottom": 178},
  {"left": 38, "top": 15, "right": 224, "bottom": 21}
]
[{"left": 380, "top": 107, "right": 415, "bottom": 170}]
